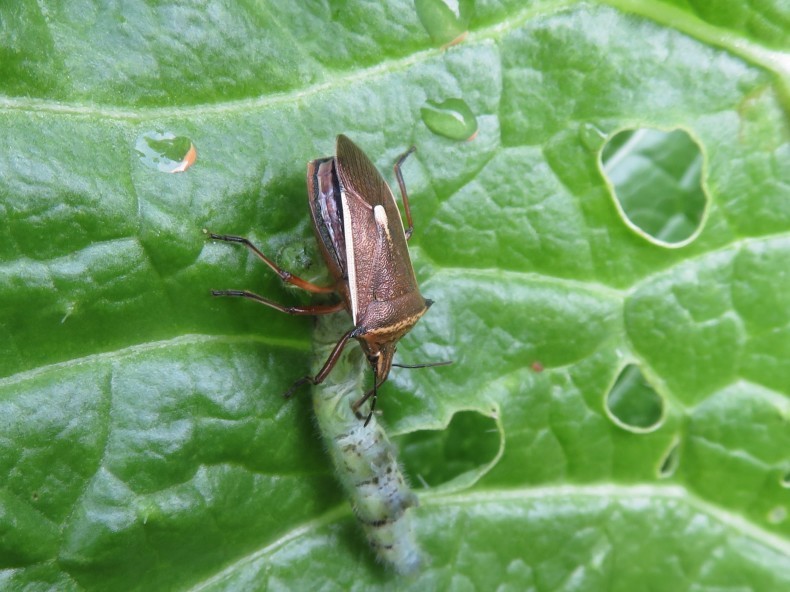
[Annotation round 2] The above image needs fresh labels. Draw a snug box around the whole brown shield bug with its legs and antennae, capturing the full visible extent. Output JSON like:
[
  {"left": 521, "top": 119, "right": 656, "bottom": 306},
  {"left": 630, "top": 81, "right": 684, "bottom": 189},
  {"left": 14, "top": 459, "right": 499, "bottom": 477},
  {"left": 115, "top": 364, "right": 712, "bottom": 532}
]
[{"left": 210, "top": 135, "right": 449, "bottom": 425}]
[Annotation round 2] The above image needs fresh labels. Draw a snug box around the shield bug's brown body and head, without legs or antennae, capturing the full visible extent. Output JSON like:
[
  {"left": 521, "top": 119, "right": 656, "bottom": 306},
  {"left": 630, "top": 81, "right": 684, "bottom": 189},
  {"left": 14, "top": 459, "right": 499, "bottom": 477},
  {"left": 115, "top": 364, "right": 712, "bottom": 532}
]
[{"left": 307, "top": 135, "right": 431, "bottom": 384}]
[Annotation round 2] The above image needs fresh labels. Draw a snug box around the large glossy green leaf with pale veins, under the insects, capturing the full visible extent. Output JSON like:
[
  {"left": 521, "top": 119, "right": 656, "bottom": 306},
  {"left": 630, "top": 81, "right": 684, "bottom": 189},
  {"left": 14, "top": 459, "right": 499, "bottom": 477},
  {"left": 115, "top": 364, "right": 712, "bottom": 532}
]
[{"left": 0, "top": 0, "right": 790, "bottom": 591}]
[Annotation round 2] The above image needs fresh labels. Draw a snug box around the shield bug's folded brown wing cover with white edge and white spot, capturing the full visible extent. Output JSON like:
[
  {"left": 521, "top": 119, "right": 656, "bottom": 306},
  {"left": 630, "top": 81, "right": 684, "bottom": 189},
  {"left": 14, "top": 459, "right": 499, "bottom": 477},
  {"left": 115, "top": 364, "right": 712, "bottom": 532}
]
[{"left": 336, "top": 135, "right": 419, "bottom": 310}]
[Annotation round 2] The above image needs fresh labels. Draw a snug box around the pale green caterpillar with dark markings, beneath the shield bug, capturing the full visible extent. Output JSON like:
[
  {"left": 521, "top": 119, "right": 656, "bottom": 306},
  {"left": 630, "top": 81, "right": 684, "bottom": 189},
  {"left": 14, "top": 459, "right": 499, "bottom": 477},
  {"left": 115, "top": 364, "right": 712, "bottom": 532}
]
[{"left": 313, "top": 314, "right": 422, "bottom": 574}]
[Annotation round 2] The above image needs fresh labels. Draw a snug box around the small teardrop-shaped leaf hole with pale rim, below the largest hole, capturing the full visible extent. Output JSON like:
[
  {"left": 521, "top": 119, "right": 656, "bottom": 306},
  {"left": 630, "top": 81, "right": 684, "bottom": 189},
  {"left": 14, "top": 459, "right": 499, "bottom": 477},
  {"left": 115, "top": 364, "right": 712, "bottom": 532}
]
[{"left": 606, "top": 364, "right": 663, "bottom": 432}]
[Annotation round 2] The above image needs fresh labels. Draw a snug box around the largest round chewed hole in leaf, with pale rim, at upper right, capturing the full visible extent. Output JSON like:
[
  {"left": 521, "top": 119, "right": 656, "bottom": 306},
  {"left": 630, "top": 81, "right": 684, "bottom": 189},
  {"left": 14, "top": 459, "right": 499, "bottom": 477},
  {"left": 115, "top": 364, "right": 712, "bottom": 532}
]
[{"left": 601, "top": 128, "right": 708, "bottom": 247}]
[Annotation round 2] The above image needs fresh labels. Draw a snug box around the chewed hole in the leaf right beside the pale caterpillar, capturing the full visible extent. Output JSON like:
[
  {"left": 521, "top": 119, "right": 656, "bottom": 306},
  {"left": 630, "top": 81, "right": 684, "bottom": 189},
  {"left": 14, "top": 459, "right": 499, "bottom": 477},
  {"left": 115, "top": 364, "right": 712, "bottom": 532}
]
[{"left": 397, "top": 411, "right": 500, "bottom": 489}]
